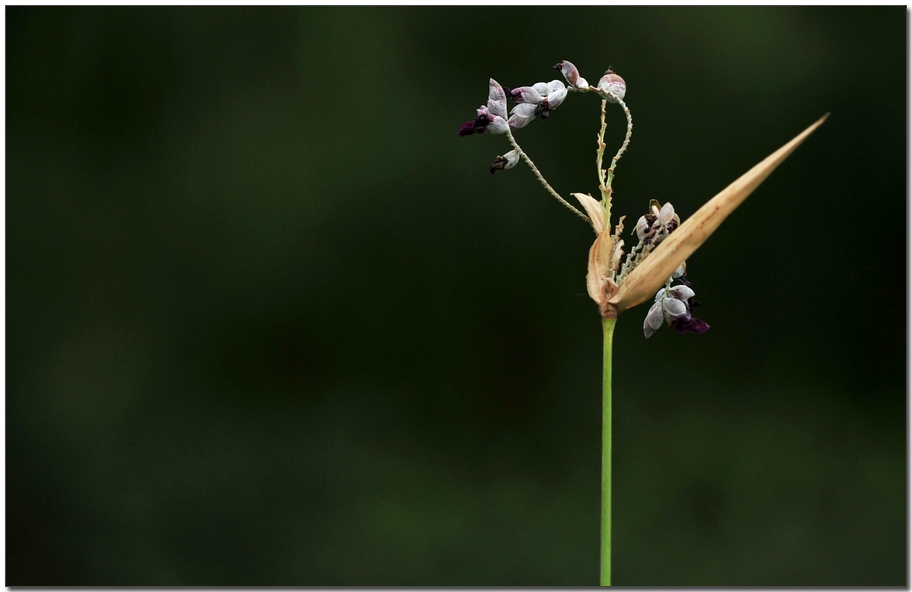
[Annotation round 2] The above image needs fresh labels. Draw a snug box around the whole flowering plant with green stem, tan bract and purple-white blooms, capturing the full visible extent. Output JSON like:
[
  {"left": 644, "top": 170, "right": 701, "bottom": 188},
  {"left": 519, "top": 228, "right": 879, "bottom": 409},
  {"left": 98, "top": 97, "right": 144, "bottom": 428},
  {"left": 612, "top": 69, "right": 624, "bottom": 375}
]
[{"left": 458, "top": 61, "right": 829, "bottom": 586}]
